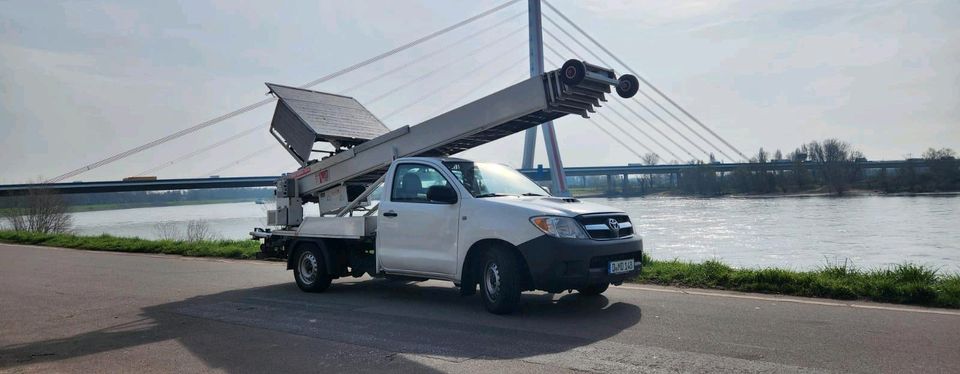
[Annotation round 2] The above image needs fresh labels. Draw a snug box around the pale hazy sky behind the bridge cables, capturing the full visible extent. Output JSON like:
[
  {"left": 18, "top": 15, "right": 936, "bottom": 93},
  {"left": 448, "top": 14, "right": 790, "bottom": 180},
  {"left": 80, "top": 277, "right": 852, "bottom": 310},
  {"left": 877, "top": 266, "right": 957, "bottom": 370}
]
[{"left": 0, "top": 0, "right": 960, "bottom": 183}]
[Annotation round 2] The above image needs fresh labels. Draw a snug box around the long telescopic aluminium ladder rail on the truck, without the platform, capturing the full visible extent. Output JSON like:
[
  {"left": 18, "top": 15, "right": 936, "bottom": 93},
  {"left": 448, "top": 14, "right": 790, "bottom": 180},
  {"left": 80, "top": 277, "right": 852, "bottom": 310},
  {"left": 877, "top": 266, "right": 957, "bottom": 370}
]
[{"left": 270, "top": 60, "right": 635, "bottom": 196}]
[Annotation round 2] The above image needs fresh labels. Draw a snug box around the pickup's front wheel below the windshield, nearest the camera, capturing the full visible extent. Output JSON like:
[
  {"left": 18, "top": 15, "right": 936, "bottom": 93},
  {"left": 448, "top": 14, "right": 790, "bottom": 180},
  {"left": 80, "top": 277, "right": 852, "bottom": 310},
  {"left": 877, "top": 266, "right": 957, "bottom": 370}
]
[{"left": 480, "top": 247, "right": 523, "bottom": 314}]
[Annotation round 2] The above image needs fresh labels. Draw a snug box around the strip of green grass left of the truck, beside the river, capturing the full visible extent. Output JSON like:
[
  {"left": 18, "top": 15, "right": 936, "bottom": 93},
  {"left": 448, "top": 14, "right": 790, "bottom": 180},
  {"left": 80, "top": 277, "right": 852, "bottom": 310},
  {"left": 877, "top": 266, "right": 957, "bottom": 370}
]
[{"left": 0, "top": 231, "right": 260, "bottom": 259}]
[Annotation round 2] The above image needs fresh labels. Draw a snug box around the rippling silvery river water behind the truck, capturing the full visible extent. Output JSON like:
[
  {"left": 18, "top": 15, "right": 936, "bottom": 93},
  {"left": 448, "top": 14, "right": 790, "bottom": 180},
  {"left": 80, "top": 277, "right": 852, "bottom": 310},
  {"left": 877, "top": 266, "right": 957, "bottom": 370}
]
[{"left": 63, "top": 195, "right": 960, "bottom": 273}]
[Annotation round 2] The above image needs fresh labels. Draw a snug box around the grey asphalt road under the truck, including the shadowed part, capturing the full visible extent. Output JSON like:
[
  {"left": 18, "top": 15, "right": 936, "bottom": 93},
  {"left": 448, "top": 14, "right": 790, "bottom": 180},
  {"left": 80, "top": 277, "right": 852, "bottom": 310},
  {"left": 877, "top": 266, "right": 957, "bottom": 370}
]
[{"left": 0, "top": 245, "right": 960, "bottom": 373}]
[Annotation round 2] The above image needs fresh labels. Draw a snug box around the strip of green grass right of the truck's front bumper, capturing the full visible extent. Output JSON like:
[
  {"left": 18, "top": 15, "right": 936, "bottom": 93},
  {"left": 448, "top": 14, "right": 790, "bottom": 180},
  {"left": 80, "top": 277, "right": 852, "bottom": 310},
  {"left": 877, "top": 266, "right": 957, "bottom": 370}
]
[{"left": 636, "top": 253, "right": 960, "bottom": 308}]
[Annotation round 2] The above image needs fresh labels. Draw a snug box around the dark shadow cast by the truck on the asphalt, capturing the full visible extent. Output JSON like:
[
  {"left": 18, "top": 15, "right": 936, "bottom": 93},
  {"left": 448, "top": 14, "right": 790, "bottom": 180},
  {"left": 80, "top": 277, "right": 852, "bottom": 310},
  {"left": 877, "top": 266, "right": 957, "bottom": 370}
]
[{"left": 0, "top": 280, "right": 641, "bottom": 372}]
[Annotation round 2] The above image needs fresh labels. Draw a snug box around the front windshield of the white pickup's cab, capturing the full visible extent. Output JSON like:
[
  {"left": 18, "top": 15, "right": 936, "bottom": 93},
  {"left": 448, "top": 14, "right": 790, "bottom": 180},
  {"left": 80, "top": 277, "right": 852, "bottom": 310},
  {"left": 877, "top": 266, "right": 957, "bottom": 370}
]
[{"left": 443, "top": 161, "right": 547, "bottom": 197}]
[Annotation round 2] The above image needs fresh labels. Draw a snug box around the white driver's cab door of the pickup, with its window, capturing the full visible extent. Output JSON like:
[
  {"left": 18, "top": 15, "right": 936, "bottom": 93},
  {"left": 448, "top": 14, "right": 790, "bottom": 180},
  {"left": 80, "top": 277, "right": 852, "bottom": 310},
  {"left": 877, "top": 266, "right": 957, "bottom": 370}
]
[{"left": 377, "top": 162, "right": 460, "bottom": 276}]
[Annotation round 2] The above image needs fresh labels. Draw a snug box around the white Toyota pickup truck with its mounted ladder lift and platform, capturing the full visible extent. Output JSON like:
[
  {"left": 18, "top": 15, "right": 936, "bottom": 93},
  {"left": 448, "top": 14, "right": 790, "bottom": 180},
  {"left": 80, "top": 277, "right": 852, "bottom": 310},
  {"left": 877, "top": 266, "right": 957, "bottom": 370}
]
[{"left": 251, "top": 60, "right": 643, "bottom": 313}]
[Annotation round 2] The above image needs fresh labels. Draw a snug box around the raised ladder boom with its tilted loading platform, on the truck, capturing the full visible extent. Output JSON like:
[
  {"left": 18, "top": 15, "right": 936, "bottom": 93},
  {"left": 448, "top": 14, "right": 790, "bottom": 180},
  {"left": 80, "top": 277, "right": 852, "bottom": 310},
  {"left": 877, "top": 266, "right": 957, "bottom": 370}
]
[{"left": 268, "top": 60, "right": 638, "bottom": 201}]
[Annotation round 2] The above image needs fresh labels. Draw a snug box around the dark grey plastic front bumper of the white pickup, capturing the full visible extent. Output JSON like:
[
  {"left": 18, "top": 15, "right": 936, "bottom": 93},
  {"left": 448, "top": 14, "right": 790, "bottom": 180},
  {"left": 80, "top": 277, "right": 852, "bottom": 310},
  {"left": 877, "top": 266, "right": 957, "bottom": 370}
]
[{"left": 517, "top": 235, "right": 643, "bottom": 292}]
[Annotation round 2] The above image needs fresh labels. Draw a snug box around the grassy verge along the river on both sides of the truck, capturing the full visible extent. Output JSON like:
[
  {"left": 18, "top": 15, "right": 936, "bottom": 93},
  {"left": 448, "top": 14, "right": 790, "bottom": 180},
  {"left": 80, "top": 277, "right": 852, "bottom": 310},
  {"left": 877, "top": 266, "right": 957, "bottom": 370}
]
[{"left": 0, "top": 231, "right": 960, "bottom": 308}]
